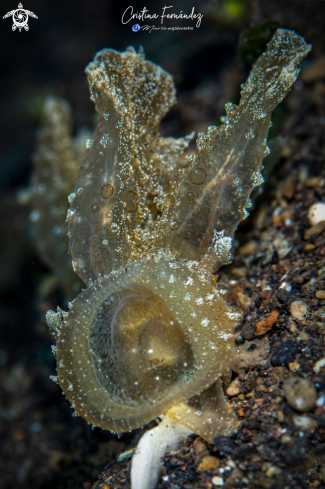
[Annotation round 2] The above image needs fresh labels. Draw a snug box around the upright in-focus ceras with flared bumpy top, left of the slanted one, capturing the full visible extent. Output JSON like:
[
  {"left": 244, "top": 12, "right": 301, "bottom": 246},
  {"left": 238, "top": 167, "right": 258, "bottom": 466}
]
[{"left": 68, "top": 48, "right": 188, "bottom": 283}]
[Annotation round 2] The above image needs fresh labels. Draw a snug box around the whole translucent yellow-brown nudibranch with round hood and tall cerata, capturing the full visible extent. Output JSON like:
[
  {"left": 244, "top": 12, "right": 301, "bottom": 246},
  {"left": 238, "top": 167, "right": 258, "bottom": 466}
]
[{"left": 48, "top": 29, "right": 310, "bottom": 487}]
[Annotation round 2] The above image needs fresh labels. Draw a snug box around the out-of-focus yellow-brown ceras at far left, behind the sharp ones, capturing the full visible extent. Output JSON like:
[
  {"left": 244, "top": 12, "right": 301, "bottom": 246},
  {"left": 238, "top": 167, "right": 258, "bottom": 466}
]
[{"left": 20, "top": 97, "right": 89, "bottom": 297}]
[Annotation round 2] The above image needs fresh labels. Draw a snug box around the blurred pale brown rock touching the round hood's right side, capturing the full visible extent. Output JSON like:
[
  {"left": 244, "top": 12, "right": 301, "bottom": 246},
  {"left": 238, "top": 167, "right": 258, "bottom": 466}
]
[{"left": 232, "top": 340, "right": 270, "bottom": 372}]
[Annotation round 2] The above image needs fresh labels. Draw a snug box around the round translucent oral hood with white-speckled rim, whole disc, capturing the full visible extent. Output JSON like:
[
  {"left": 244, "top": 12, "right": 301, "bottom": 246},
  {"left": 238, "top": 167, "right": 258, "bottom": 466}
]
[{"left": 57, "top": 254, "right": 233, "bottom": 431}]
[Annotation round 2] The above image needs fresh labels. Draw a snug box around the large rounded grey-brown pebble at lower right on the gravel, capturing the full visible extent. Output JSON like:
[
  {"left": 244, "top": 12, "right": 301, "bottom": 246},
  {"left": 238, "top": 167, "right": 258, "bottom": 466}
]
[{"left": 283, "top": 377, "right": 317, "bottom": 413}]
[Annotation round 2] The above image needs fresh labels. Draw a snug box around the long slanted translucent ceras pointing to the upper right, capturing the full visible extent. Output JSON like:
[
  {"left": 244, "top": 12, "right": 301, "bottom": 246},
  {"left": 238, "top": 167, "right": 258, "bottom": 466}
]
[{"left": 157, "top": 29, "right": 310, "bottom": 271}]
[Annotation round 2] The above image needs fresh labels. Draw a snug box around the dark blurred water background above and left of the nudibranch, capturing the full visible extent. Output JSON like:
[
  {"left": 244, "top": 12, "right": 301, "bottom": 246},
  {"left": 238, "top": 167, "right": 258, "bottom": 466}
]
[{"left": 0, "top": 0, "right": 325, "bottom": 489}]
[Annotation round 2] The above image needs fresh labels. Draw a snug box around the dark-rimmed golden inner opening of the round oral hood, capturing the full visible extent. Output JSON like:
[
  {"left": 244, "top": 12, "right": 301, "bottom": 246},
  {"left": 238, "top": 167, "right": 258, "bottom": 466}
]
[{"left": 90, "top": 284, "right": 195, "bottom": 405}]
